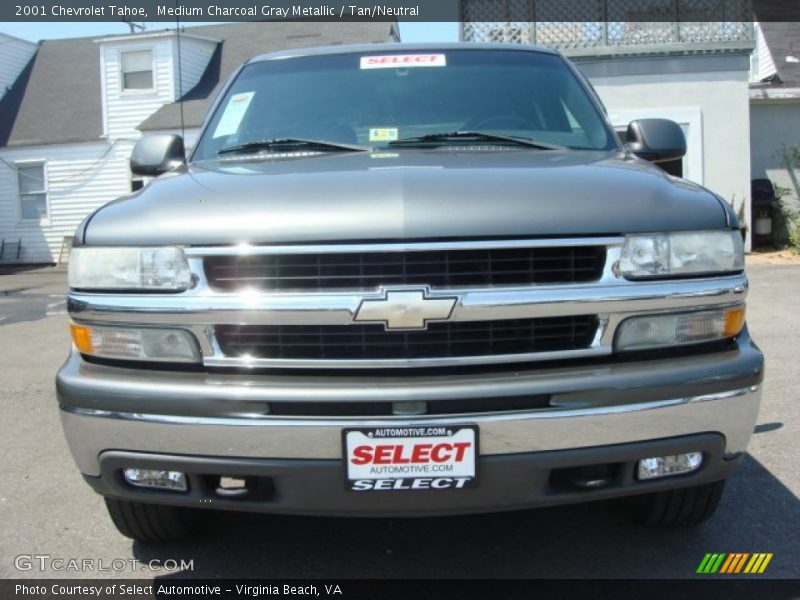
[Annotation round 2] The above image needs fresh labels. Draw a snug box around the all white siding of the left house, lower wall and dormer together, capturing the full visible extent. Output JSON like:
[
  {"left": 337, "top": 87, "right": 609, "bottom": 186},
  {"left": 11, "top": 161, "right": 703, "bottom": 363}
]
[{"left": 0, "top": 36, "right": 216, "bottom": 263}]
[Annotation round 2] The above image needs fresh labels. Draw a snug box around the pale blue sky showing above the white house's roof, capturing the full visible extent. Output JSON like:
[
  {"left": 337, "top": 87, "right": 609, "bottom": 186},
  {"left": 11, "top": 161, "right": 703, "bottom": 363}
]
[{"left": 0, "top": 20, "right": 458, "bottom": 42}]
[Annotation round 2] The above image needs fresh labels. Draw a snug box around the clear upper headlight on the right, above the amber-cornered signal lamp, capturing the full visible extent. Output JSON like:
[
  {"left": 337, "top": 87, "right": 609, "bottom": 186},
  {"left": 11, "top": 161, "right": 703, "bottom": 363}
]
[{"left": 619, "top": 231, "right": 744, "bottom": 279}]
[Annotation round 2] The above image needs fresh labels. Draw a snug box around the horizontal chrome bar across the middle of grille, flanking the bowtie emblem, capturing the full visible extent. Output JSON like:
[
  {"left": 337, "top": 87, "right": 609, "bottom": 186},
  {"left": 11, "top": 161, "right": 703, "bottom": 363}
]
[{"left": 69, "top": 275, "right": 747, "bottom": 326}]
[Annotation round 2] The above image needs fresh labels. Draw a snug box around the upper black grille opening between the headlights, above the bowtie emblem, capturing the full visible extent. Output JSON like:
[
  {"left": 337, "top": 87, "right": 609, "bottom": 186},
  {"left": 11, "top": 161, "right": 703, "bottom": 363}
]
[{"left": 204, "top": 246, "right": 606, "bottom": 291}]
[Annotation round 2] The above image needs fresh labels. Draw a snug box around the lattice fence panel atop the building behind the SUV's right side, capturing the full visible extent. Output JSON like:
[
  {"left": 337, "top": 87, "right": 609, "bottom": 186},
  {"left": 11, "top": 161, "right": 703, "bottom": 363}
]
[{"left": 461, "top": 0, "right": 753, "bottom": 50}]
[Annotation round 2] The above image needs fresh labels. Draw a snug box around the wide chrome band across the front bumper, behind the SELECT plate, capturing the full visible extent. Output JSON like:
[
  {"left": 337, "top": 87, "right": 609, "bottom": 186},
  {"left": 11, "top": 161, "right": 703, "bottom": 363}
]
[{"left": 61, "top": 386, "right": 761, "bottom": 475}]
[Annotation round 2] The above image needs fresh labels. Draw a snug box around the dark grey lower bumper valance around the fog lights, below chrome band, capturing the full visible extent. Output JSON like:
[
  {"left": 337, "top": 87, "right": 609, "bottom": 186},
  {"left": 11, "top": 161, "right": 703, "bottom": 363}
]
[{"left": 85, "top": 433, "right": 742, "bottom": 517}]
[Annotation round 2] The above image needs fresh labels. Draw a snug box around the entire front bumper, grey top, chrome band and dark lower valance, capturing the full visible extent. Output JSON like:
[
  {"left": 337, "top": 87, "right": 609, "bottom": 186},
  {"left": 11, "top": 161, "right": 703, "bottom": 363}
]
[{"left": 57, "top": 331, "right": 763, "bottom": 514}]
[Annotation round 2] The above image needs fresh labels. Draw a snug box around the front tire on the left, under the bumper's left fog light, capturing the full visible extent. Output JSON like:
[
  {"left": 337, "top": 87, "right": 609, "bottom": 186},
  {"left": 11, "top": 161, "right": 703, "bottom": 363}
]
[{"left": 105, "top": 498, "right": 199, "bottom": 544}]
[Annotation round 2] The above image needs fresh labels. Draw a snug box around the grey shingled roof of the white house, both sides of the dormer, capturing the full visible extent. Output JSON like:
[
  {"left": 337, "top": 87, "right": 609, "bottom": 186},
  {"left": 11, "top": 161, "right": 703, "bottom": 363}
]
[{"left": 0, "top": 21, "right": 395, "bottom": 147}]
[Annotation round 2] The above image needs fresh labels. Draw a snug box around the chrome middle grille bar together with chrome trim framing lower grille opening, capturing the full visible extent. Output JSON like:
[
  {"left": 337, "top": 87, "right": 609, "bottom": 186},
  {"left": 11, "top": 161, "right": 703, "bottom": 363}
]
[{"left": 69, "top": 275, "right": 747, "bottom": 369}]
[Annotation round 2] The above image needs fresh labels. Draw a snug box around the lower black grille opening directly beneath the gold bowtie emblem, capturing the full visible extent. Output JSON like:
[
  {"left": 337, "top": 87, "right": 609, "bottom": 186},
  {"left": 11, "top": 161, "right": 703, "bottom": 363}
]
[{"left": 215, "top": 315, "right": 597, "bottom": 360}]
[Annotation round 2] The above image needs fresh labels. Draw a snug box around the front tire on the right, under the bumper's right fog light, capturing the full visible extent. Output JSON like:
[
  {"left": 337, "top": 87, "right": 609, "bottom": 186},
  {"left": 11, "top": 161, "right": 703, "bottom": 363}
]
[{"left": 634, "top": 479, "right": 725, "bottom": 528}]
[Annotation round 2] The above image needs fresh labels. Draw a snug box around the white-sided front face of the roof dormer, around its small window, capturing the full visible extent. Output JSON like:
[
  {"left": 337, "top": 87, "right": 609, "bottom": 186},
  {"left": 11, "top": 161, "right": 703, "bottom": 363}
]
[{"left": 100, "top": 38, "right": 176, "bottom": 140}]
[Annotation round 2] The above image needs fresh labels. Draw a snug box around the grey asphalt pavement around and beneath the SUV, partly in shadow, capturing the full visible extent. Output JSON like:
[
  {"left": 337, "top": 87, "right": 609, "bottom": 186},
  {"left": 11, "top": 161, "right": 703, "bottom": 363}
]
[{"left": 0, "top": 265, "right": 800, "bottom": 579}]
